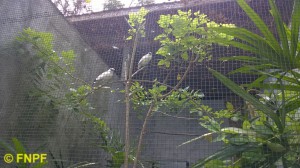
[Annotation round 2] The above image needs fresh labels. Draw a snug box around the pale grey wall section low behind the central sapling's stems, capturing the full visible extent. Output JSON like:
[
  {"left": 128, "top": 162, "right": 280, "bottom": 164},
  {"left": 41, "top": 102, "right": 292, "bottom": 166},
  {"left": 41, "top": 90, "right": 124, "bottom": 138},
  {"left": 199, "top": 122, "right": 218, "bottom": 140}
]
[{"left": 142, "top": 100, "right": 225, "bottom": 168}]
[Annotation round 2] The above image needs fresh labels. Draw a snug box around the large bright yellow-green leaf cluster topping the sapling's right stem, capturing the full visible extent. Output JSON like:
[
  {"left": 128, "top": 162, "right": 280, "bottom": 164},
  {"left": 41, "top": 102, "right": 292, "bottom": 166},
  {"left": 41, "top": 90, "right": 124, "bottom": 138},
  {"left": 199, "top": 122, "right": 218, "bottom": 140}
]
[{"left": 155, "top": 10, "right": 234, "bottom": 67}]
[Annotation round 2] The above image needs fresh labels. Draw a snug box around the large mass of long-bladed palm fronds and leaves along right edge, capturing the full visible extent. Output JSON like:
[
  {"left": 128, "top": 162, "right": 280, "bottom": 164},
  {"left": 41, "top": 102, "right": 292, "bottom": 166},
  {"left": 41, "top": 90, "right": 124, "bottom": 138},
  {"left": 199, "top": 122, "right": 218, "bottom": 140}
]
[{"left": 183, "top": 0, "right": 300, "bottom": 167}]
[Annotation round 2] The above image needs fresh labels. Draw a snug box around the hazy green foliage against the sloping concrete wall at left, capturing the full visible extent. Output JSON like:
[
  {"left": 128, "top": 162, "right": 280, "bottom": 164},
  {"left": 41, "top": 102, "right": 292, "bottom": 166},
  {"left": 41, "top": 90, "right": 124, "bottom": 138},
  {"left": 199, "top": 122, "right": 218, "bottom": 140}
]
[{"left": 15, "top": 28, "right": 91, "bottom": 111}]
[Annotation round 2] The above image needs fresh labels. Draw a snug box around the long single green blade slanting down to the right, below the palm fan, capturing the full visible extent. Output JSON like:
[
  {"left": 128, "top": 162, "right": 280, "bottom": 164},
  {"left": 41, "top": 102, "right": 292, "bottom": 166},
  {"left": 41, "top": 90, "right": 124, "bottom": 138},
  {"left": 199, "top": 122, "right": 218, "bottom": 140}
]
[{"left": 209, "top": 68, "right": 283, "bottom": 131}]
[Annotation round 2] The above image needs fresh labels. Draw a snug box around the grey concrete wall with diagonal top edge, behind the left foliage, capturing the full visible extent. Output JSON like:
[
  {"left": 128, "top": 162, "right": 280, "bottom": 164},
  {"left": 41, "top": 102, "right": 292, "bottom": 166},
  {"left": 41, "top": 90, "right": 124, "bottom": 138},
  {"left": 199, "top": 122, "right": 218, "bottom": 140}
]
[{"left": 0, "top": 0, "right": 123, "bottom": 167}]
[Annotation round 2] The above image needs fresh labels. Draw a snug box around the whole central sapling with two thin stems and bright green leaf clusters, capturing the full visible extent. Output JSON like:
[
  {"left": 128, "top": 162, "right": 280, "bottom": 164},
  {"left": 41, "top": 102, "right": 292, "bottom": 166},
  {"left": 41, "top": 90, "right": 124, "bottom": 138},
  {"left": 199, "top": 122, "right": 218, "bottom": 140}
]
[{"left": 125, "top": 8, "right": 234, "bottom": 167}]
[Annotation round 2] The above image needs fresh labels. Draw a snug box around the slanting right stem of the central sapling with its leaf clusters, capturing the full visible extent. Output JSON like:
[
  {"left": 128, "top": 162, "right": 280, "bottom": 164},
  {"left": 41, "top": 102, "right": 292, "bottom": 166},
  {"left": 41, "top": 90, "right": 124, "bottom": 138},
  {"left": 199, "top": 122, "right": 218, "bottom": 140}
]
[{"left": 126, "top": 10, "right": 233, "bottom": 168}]
